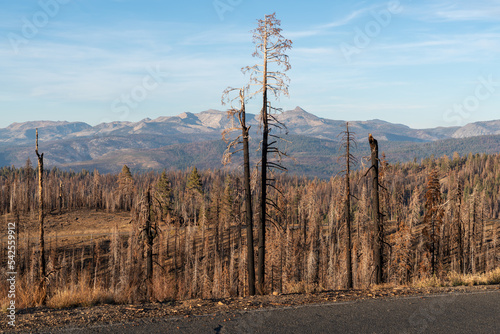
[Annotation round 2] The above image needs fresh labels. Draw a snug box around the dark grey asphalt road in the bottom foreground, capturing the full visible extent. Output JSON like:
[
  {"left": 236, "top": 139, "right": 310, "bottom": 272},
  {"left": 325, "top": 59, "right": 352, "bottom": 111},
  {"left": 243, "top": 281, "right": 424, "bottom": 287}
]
[{"left": 53, "top": 291, "right": 500, "bottom": 334}]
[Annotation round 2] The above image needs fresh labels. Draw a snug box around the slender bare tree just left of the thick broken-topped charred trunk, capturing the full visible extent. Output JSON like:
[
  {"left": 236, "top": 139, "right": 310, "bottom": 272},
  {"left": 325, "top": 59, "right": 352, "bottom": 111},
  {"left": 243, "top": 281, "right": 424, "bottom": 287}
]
[{"left": 339, "top": 122, "right": 357, "bottom": 289}]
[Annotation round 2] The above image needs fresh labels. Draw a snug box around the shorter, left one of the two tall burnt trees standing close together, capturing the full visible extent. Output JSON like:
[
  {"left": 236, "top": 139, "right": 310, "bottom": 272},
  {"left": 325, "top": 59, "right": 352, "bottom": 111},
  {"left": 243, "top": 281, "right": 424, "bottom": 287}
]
[{"left": 222, "top": 88, "right": 255, "bottom": 296}]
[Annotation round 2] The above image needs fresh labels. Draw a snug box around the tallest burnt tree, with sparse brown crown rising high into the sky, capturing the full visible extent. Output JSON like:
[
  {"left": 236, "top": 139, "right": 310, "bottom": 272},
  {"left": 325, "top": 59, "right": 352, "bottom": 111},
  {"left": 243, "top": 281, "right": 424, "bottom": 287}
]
[{"left": 242, "top": 13, "right": 292, "bottom": 294}]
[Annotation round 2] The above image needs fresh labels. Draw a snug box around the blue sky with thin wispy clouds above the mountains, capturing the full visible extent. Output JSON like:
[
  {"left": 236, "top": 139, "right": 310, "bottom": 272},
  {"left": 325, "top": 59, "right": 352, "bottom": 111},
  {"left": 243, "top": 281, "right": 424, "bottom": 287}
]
[{"left": 0, "top": 0, "right": 500, "bottom": 128}]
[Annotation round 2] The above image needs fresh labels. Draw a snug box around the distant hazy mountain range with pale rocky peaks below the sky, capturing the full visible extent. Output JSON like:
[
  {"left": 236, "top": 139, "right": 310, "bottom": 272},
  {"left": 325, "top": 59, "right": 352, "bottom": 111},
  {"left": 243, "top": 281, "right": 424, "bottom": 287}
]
[{"left": 0, "top": 107, "right": 500, "bottom": 177}]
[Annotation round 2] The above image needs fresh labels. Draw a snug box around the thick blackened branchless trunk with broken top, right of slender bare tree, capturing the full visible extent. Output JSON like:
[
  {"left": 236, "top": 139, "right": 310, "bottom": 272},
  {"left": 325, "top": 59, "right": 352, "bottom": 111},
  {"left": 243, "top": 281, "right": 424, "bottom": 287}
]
[{"left": 368, "top": 134, "right": 384, "bottom": 284}]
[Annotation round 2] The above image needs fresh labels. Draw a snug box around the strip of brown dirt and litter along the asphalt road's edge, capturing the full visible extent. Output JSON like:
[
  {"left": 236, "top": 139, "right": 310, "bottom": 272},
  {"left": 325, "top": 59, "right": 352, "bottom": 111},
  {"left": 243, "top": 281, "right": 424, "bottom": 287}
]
[{"left": 0, "top": 285, "right": 500, "bottom": 333}]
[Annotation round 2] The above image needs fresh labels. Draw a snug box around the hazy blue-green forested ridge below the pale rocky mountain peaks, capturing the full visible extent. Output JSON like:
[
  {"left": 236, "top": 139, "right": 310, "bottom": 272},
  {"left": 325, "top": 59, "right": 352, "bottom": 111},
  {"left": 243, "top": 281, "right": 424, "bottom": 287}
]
[{"left": 0, "top": 131, "right": 500, "bottom": 179}]
